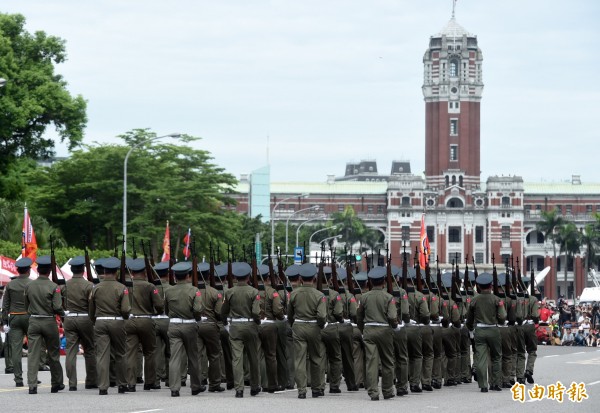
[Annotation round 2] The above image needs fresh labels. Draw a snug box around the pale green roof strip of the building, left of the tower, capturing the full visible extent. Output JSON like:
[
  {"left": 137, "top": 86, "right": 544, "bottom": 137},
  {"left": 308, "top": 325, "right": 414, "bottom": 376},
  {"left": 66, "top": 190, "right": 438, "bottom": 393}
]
[{"left": 234, "top": 181, "right": 387, "bottom": 195}]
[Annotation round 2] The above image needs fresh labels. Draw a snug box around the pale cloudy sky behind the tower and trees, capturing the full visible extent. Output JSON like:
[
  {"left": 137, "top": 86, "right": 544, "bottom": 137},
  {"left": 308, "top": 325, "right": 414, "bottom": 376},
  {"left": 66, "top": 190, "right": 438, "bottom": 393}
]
[{"left": 0, "top": 0, "right": 600, "bottom": 183}]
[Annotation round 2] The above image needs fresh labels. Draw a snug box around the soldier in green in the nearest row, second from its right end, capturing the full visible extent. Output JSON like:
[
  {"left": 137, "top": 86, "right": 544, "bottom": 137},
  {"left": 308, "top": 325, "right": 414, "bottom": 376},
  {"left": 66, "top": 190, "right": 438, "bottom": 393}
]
[{"left": 357, "top": 267, "right": 398, "bottom": 401}]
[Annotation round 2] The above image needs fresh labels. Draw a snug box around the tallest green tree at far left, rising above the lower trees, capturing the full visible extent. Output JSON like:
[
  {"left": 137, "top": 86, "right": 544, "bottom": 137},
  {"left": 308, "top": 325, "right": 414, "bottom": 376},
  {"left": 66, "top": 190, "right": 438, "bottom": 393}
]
[{"left": 0, "top": 13, "right": 87, "bottom": 177}]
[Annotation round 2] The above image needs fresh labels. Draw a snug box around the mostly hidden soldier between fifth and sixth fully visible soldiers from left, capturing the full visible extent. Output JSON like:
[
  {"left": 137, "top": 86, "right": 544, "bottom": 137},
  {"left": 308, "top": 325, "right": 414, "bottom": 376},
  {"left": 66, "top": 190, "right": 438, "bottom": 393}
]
[{"left": 152, "top": 261, "right": 171, "bottom": 387}]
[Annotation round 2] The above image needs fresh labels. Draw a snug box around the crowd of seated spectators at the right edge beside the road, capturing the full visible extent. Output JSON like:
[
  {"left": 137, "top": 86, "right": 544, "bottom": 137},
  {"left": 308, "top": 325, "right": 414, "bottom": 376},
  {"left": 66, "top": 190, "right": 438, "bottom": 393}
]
[{"left": 537, "top": 299, "right": 600, "bottom": 347}]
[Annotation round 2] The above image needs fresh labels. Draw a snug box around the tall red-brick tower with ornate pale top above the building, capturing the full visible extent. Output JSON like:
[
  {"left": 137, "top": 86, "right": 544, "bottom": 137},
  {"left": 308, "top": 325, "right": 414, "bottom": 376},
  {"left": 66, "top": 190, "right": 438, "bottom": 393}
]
[{"left": 423, "top": 12, "right": 483, "bottom": 189}]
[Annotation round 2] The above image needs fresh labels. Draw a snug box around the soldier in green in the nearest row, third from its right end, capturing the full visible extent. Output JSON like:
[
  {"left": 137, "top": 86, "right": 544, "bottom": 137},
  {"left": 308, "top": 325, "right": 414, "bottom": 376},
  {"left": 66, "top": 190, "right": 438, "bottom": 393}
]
[{"left": 288, "top": 264, "right": 327, "bottom": 399}]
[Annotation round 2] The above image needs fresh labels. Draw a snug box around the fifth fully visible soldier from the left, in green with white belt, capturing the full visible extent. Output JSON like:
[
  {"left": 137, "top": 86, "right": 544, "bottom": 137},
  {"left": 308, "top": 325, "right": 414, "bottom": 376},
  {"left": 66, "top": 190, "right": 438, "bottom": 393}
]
[{"left": 125, "top": 258, "right": 164, "bottom": 392}]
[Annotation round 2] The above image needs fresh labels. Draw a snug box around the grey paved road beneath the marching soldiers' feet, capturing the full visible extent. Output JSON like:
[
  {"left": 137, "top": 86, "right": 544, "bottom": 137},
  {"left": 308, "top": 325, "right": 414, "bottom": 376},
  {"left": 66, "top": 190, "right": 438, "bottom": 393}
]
[{"left": 0, "top": 346, "right": 600, "bottom": 413}]
